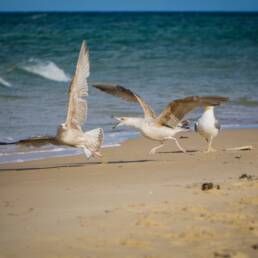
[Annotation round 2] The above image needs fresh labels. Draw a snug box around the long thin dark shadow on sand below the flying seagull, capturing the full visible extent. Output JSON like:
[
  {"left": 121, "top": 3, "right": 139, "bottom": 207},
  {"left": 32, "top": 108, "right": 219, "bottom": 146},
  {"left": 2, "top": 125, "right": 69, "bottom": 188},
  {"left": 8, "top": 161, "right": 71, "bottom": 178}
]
[{"left": 0, "top": 159, "right": 155, "bottom": 172}]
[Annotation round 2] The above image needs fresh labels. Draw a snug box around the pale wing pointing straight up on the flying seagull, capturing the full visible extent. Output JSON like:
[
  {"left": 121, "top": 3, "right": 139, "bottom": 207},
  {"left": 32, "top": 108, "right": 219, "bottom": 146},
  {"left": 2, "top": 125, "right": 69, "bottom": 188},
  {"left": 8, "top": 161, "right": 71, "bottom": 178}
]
[{"left": 66, "top": 41, "right": 90, "bottom": 131}]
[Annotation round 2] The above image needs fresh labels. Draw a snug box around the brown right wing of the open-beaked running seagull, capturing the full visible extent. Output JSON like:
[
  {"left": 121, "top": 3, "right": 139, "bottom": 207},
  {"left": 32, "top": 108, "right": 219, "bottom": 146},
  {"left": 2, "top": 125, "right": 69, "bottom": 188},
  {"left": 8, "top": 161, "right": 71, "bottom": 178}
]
[{"left": 156, "top": 96, "right": 228, "bottom": 127}]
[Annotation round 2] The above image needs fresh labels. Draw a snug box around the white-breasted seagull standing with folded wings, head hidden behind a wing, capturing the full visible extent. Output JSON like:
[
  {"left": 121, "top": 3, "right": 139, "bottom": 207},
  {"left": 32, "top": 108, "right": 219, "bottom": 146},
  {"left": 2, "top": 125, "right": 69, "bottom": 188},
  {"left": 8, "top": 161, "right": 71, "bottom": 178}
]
[{"left": 194, "top": 105, "right": 228, "bottom": 153}]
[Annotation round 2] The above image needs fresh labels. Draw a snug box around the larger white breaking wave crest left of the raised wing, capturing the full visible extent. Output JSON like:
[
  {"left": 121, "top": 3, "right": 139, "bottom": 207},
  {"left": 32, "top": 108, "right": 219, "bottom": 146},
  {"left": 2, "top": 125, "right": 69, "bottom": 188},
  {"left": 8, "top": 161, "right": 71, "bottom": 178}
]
[{"left": 20, "top": 58, "right": 71, "bottom": 82}]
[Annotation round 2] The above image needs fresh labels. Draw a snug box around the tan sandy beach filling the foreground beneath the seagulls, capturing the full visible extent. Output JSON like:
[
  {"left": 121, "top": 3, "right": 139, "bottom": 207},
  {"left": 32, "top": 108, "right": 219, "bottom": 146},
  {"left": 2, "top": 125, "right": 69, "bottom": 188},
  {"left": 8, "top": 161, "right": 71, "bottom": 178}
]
[{"left": 0, "top": 129, "right": 258, "bottom": 258}]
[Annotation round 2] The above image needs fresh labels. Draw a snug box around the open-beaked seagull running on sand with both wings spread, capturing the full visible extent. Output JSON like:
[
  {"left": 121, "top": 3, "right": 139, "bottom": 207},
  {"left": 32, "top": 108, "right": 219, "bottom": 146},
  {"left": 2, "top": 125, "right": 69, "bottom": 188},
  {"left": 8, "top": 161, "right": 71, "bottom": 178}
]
[{"left": 93, "top": 83, "right": 226, "bottom": 154}]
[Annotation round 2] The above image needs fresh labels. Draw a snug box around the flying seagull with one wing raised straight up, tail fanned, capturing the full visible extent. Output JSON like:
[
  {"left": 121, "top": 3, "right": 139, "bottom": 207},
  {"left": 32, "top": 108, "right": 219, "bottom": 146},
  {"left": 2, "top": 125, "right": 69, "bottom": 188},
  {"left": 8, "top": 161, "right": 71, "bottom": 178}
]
[{"left": 1, "top": 41, "right": 104, "bottom": 159}]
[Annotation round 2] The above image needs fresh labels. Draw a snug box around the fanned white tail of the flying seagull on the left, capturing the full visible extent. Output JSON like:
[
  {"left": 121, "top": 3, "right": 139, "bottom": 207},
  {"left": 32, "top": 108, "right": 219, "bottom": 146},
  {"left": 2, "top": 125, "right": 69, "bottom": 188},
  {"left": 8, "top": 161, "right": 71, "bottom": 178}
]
[{"left": 84, "top": 128, "right": 104, "bottom": 152}]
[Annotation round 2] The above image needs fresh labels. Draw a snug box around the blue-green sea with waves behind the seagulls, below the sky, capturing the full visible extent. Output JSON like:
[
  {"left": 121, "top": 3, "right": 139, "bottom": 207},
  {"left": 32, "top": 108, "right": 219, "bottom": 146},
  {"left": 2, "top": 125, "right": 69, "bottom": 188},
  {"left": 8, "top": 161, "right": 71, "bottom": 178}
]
[{"left": 0, "top": 12, "right": 258, "bottom": 163}]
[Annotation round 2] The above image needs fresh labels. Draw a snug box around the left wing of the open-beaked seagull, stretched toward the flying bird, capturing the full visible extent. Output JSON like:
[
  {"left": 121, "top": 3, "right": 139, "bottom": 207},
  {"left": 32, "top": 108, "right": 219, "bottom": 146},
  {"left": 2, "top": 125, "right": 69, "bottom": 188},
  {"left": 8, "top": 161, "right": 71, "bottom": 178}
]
[{"left": 93, "top": 83, "right": 156, "bottom": 118}]
